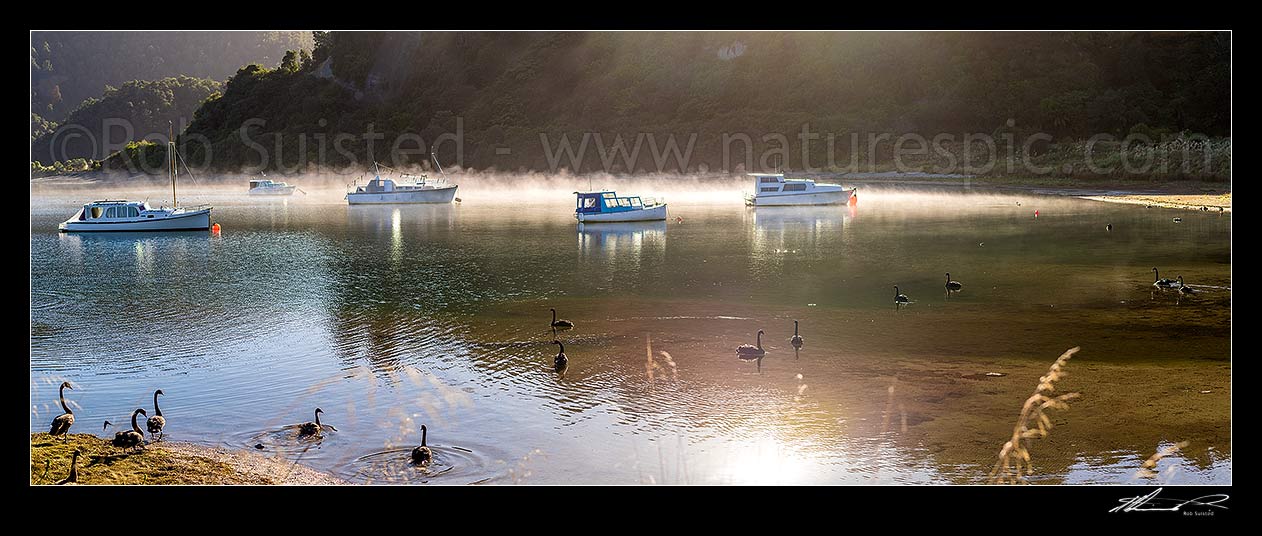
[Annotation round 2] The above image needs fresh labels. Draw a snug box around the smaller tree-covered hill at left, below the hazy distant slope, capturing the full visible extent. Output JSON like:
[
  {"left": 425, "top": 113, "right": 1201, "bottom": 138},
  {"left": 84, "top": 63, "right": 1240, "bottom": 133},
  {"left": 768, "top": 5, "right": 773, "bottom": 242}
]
[{"left": 32, "top": 76, "right": 222, "bottom": 163}]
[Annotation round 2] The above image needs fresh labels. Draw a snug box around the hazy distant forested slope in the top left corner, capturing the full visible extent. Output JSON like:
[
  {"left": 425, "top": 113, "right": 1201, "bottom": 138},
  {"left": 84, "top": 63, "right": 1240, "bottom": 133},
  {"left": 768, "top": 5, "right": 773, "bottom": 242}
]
[{"left": 30, "top": 32, "right": 313, "bottom": 121}]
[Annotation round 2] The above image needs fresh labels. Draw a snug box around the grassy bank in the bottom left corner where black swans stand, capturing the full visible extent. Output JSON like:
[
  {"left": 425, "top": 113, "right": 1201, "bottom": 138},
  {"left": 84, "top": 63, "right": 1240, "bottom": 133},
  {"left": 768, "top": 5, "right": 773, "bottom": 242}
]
[{"left": 30, "top": 434, "right": 341, "bottom": 486}]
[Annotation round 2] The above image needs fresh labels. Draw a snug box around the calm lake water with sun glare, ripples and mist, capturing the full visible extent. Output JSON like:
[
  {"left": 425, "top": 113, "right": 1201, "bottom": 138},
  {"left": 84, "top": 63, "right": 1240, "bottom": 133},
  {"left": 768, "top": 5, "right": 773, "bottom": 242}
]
[{"left": 30, "top": 180, "right": 1232, "bottom": 484}]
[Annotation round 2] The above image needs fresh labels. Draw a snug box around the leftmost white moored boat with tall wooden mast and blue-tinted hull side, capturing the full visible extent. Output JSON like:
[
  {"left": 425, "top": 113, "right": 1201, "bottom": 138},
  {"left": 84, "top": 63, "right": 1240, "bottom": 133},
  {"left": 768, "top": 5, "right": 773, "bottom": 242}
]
[{"left": 57, "top": 131, "right": 212, "bottom": 232}]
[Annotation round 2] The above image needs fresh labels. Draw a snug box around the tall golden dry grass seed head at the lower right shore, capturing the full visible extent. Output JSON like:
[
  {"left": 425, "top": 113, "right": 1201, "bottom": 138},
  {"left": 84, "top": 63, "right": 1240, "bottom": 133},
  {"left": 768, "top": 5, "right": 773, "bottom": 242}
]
[{"left": 989, "top": 347, "right": 1079, "bottom": 484}]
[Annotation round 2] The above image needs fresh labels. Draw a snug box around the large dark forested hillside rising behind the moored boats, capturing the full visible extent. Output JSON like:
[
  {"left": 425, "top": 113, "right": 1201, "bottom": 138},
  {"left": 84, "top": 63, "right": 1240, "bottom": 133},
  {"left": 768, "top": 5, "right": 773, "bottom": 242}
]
[{"left": 172, "top": 32, "right": 1230, "bottom": 172}]
